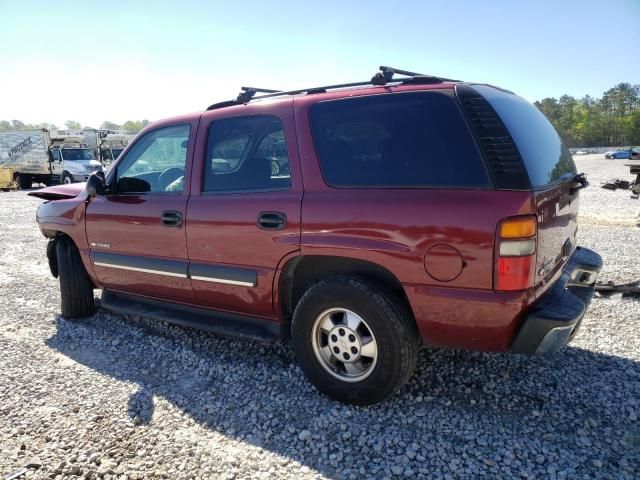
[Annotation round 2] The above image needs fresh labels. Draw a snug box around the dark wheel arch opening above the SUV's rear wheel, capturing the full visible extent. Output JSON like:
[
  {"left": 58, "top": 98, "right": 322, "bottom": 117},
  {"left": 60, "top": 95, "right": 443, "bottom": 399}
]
[{"left": 278, "top": 255, "right": 417, "bottom": 328}]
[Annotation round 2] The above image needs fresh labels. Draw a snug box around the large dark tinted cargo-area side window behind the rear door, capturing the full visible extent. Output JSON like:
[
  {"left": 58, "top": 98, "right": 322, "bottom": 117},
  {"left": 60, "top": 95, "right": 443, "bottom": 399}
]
[{"left": 311, "top": 92, "right": 490, "bottom": 188}]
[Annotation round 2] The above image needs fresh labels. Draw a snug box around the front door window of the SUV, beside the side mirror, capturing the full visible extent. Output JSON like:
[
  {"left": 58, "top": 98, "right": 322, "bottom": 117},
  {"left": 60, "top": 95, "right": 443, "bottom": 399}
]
[{"left": 117, "top": 125, "right": 191, "bottom": 193}]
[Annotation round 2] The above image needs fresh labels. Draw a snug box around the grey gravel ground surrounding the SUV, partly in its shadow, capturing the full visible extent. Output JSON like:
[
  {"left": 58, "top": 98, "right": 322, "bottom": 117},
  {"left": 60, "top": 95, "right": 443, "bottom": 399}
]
[{"left": 0, "top": 156, "right": 640, "bottom": 479}]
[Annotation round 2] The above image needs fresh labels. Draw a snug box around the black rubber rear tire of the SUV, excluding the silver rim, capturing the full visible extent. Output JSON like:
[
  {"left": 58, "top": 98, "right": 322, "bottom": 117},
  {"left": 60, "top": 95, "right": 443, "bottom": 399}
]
[{"left": 291, "top": 276, "right": 419, "bottom": 405}]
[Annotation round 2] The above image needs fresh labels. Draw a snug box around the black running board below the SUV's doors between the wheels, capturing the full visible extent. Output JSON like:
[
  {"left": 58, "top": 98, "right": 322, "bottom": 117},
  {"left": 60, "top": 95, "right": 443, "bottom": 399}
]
[{"left": 100, "top": 290, "right": 282, "bottom": 342}]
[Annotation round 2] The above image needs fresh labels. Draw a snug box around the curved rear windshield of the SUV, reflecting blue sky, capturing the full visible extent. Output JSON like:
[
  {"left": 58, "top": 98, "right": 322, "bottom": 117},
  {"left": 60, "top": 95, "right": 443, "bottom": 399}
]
[{"left": 473, "top": 85, "right": 576, "bottom": 188}]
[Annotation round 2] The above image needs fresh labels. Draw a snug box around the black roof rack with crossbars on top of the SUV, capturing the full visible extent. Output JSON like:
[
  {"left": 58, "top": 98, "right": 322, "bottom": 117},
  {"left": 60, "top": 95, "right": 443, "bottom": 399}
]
[{"left": 207, "top": 66, "right": 459, "bottom": 110}]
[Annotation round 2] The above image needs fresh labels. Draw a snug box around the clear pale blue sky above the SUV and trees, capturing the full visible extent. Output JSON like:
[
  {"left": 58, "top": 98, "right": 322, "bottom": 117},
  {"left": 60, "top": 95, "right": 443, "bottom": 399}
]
[{"left": 0, "top": 0, "right": 640, "bottom": 126}]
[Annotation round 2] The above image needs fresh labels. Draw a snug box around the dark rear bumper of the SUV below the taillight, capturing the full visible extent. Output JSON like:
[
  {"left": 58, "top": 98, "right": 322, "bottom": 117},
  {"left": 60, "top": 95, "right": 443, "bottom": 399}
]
[{"left": 511, "top": 247, "right": 602, "bottom": 354}]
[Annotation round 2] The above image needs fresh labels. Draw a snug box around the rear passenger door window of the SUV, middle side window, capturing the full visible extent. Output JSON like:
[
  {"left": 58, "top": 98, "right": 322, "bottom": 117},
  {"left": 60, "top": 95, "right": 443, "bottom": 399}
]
[{"left": 204, "top": 115, "right": 291, "bottom": 192}]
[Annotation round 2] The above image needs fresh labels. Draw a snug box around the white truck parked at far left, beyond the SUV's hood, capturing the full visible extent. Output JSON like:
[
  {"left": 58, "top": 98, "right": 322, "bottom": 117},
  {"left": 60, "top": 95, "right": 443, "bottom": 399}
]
[{"left": 0, "top": 129, "right": 103, "bottom": 189}]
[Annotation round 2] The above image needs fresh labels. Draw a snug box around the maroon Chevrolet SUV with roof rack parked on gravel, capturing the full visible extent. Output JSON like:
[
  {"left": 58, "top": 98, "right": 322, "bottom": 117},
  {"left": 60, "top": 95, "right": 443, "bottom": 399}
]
[{"left": 31, "top": 67, "right": 602, "bottom": 404}]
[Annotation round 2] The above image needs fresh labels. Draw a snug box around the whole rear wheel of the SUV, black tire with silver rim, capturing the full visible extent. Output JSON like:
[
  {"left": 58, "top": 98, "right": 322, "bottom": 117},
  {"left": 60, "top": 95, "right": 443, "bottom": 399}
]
[{"left": 291, "top": 277, "right": 418, "bottom": 405}]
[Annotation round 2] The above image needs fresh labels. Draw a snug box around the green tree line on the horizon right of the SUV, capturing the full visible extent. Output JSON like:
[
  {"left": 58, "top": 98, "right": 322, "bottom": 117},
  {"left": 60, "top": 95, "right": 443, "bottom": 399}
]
[{"left": 533, "top": 83, "right": 640, "bottom": 147}]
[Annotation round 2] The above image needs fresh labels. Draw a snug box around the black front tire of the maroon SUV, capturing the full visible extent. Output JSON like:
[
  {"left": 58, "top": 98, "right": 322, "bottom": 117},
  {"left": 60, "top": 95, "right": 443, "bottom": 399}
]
[{"left": 56, "top": 237, "right": 96, "bottom": 319}]
